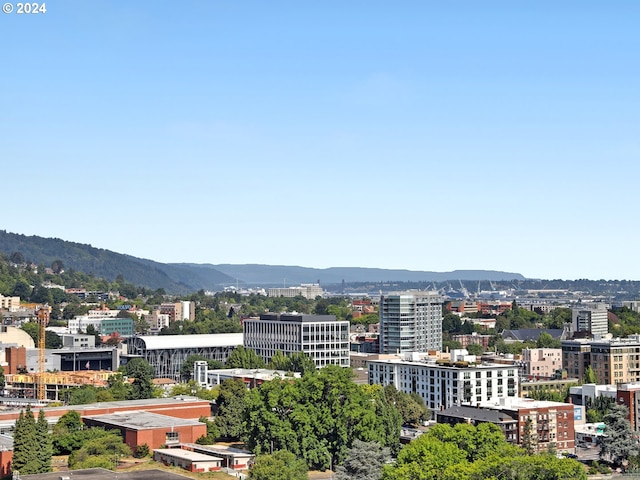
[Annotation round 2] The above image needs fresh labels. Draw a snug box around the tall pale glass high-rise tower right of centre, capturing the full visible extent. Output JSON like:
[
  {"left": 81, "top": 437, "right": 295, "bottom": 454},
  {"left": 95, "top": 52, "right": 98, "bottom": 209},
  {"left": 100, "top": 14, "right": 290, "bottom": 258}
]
[{"left": 380, "top": 291, "right": 442, "bottom": 353}]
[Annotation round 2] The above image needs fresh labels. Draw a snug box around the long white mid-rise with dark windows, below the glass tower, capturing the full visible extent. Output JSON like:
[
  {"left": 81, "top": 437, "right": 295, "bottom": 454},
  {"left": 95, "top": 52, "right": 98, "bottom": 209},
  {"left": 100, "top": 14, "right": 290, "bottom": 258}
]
[{"left": 368, "top": 359, "right": 518, "bottom": 411}]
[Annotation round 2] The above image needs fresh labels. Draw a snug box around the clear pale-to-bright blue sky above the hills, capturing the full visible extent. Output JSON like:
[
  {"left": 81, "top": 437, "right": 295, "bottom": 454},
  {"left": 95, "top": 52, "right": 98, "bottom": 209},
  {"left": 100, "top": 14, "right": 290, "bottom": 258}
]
[{"left": 0, "top": 0, "right": 640, "bottom": 280}]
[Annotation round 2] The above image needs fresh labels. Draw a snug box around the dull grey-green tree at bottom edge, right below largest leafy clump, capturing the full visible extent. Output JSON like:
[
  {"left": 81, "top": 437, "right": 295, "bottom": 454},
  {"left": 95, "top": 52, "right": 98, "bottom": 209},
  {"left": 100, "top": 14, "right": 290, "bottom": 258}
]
[{"left": 336, "top": 440, "right": 391, "bottom": 480}]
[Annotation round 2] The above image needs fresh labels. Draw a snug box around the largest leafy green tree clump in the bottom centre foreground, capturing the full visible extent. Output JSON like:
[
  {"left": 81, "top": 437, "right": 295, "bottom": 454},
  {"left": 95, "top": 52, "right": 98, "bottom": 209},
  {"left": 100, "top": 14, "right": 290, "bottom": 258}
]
[{"left": 244, "top": 365, "right": 400, "bottom": 469}]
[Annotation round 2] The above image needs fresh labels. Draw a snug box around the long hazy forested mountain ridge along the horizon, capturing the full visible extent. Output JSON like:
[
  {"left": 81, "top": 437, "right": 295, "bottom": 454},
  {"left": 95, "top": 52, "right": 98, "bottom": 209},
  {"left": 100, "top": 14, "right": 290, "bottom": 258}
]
[{"left": 0, "top": 230, "right": 525, "bottom": 294}]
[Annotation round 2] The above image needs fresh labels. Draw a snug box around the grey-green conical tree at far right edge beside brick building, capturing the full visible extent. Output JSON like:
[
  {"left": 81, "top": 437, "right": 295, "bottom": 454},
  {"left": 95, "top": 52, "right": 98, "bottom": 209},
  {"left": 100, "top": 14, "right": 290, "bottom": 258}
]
[{"left": 600, "top": 404, "right": 640, "bottom": 467}]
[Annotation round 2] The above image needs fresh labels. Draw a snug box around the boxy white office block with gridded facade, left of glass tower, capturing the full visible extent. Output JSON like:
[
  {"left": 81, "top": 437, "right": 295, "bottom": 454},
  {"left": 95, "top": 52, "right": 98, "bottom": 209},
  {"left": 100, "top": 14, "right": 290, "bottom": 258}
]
[{"left": 242, "top": 313, "right": 349, "bottom": 368}]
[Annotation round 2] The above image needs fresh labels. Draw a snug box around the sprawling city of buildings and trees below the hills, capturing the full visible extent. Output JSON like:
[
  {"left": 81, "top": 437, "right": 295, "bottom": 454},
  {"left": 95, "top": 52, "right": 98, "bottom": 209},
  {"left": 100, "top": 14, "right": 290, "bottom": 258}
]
[{"left": 0, "top": 246, "right": 640, "bottom": 478}]
